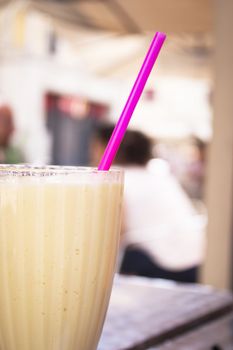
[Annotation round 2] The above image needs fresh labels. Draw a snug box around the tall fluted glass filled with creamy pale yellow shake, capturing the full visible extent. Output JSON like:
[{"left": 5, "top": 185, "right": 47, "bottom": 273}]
[{"left": 0, "top": 165, "right": 123, "bottom": 350}]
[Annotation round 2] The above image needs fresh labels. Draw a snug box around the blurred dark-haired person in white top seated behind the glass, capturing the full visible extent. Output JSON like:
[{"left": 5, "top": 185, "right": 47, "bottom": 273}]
[{"left": 93, "top": 125, "right": 204, "bottom": 282}]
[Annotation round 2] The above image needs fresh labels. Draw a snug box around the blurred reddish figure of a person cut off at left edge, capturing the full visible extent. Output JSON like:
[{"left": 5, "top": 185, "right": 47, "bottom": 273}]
[{"left": 0, "top": 105, "right": 23, "bottom": 164}]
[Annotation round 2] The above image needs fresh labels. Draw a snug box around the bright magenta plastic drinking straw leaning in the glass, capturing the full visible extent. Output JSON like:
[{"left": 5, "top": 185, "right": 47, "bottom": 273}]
[{"left": 98, "top": 32, "right": 166, "bottom": 170}]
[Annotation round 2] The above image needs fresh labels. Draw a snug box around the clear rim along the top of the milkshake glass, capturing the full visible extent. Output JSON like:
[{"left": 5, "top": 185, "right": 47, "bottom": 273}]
[{"left": 0, "top": 163, "right": 123, "bottom": 177}]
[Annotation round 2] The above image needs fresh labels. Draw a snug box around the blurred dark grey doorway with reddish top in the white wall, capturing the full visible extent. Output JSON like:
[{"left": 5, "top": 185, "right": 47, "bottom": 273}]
[{"left": 45, "top": 92, "right": 109, "bottom": 166}]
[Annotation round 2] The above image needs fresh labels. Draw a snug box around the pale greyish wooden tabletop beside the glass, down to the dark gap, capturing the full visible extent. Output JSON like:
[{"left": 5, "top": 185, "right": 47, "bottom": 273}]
[{"left": 98, "top": 276, "right": 233, "bottom": 350}]
